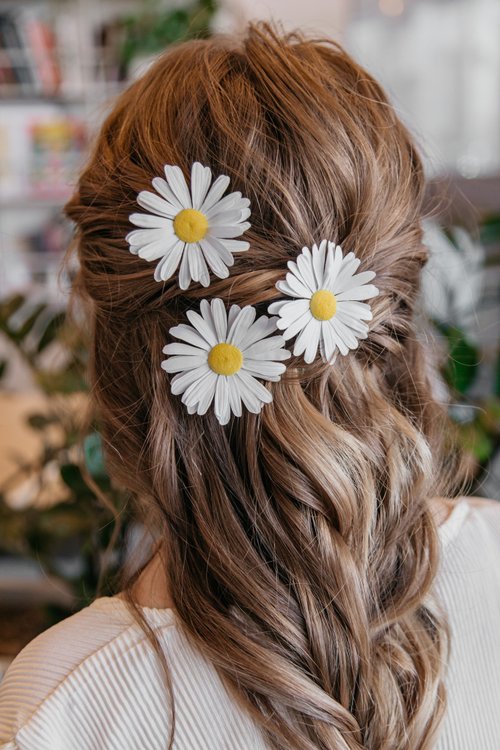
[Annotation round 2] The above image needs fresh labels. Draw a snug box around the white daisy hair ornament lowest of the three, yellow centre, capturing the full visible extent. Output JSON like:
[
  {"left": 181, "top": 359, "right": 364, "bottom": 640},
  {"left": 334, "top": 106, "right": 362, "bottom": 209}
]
[{"left": 161, "top": 299, "right": 291, "bottom": 424}]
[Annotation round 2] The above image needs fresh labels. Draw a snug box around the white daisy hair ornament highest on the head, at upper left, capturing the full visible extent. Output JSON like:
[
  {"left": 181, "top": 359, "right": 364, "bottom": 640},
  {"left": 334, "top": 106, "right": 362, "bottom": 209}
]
[{"left": 126, "top": 162, "right": 250, "bottom": 289}]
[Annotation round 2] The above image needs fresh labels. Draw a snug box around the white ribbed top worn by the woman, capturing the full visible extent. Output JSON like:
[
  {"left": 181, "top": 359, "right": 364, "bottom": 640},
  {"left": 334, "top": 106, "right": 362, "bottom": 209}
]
[{"left": 0, "top": 500, "right": 500, "bottom": 750}]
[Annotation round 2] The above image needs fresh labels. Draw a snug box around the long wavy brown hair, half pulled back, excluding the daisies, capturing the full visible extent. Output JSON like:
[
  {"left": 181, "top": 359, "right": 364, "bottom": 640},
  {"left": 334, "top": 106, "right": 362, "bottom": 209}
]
[{"left": 67, "top": 24, "right": 466, "bottom": 750}]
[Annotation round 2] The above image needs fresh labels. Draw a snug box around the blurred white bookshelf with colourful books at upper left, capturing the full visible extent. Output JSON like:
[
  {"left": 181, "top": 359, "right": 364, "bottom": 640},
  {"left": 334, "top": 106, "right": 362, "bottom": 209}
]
[{"left": 0, "top": 0, "right": 141, "bottom": 304}]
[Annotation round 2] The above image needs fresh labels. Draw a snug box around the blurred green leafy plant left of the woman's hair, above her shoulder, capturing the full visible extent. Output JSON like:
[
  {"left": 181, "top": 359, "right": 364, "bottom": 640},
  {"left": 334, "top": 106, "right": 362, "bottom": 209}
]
[{"left": 0, "top": 295, "right": 130, "bottom": 623}]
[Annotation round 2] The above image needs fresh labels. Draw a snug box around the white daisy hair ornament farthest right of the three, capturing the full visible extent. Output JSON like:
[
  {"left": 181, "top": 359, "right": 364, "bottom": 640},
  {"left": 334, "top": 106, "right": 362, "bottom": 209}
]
[{"left": 268, "top": 240, "right": 378, "bottom": 363}]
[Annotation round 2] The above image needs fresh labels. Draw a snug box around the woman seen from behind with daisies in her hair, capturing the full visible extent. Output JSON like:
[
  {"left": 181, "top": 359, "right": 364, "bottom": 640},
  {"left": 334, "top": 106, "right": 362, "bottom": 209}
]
[{"left": 0, "top": 26, "right": 500, "bottom": 750}]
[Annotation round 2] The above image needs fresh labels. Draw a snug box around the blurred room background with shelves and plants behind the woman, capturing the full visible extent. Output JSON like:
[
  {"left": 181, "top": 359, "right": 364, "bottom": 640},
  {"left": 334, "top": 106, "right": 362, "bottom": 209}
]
[{"left": 0, "top": 0, "right": 500, "bottom": 678}]
